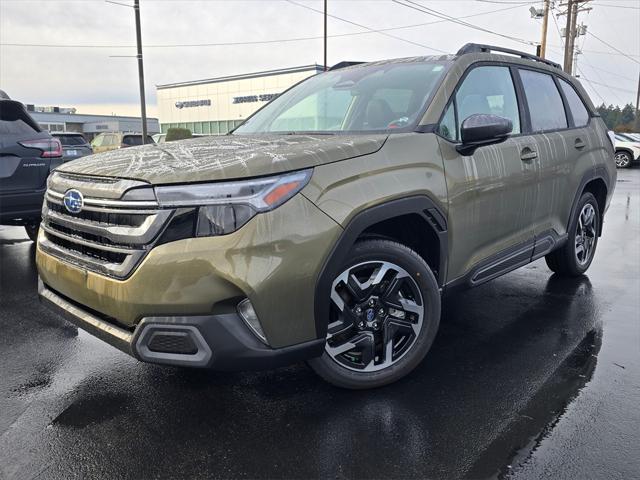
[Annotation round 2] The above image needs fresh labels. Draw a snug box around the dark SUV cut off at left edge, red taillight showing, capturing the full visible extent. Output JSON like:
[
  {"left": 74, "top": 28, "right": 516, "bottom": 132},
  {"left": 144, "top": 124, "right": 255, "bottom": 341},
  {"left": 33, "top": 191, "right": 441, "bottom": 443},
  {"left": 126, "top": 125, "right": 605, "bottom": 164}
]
[{"left": 0, "top": 90, "right": 62, "bottom": 241}]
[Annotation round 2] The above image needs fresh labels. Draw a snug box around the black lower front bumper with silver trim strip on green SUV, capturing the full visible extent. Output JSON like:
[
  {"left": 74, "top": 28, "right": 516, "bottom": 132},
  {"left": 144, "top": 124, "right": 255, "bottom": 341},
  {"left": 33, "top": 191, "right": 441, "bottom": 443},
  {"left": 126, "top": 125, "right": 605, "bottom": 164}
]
[{"left": 38, "top": 280, "right": 324, "bottom": 371}]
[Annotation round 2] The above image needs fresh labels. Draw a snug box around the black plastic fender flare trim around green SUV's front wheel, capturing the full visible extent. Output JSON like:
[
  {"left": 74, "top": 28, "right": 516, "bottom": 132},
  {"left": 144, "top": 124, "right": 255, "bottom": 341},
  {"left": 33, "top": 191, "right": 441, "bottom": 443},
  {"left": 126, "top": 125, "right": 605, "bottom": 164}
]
[{"left": 314, "top": 195, "right": 448, "bottom": 338}]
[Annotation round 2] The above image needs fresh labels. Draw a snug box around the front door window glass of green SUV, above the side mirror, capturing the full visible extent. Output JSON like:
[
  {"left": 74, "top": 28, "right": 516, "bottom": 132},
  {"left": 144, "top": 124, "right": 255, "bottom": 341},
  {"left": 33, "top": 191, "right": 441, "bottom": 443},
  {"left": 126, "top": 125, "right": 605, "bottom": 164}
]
[{"left": 456, "top": 66, "right": 520, "bottom": 133}]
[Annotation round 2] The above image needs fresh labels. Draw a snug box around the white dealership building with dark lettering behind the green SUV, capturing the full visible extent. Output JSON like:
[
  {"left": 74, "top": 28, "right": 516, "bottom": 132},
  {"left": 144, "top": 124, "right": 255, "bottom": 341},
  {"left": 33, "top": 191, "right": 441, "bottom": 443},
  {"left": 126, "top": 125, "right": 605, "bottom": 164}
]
[{"left": 156, "top": 65, "right": 323, "bottom": 135}]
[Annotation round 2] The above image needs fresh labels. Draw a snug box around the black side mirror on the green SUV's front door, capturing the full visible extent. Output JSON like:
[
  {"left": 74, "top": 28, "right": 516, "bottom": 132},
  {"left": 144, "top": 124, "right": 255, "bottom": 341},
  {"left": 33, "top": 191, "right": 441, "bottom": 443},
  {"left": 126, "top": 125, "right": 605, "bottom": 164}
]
[{"left": 456, "top": 113, "right": 513, "bottom": 156}]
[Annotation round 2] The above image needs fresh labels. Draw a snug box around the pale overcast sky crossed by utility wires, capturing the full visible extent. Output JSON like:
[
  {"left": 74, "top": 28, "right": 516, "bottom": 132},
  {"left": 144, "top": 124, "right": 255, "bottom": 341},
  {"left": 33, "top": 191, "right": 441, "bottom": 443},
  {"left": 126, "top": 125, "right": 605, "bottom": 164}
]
[{"left": 0, "top": 0, "right": 640, "bottom": 115}]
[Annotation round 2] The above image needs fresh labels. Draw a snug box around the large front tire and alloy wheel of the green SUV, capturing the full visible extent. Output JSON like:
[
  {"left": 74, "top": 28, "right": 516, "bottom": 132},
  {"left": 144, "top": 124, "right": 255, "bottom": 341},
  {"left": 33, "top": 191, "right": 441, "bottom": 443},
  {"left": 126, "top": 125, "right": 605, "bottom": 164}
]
[{"left": 309, "top": 240, "right": 440, "bottom": 389}]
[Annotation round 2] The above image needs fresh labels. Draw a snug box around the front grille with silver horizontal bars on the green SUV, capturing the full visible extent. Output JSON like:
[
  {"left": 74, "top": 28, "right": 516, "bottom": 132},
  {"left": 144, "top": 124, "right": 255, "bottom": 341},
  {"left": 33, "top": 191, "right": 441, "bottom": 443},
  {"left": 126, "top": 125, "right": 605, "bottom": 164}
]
[{"left": 40, "top": 178, "right": 174, "bottom": 279}]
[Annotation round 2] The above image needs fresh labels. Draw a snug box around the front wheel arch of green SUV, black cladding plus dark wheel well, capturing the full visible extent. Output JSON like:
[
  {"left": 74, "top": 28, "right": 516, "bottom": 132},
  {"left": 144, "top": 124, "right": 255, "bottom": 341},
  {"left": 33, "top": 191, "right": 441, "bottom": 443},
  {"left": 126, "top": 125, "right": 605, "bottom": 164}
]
[{"left": 314, "top": 195, "right": 448, "bottom": 338}]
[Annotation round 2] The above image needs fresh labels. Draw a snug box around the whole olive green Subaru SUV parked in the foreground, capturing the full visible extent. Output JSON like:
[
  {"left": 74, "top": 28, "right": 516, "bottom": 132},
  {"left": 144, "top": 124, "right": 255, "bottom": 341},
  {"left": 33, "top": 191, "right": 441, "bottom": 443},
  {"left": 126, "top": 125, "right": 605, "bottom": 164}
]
[{"left": 37, "top": 44, "right": 616, "bottom": 388}]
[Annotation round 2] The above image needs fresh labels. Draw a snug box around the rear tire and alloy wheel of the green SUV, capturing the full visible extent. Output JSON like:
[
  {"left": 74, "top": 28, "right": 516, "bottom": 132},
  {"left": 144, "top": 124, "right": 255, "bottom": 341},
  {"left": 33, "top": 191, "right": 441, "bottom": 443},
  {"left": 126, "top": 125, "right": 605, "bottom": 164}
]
[{"left": 545, "top": 192, "right": 601, "bottom": 277}]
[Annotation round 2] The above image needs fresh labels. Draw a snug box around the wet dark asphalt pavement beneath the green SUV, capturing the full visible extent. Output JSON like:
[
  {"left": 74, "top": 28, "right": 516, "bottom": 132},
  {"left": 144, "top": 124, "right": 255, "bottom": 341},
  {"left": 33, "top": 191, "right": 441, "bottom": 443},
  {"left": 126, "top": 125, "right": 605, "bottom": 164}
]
[{"left": 0, "top": 168, "right": 640, "bottom": 479}]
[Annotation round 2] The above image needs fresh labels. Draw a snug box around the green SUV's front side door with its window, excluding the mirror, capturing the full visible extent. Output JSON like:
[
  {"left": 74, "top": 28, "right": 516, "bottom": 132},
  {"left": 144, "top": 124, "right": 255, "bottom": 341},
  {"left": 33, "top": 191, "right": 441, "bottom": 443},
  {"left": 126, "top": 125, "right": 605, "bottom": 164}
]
[{"left": 438, "top": 64, "right": 538, "bottom": 283}]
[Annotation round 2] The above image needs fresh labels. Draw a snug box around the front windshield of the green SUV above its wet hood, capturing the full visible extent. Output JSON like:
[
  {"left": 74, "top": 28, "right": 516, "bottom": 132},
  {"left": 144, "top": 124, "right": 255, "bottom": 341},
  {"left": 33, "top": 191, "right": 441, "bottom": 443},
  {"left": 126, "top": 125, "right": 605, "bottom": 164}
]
[{"left": 233, "top": 61, "right": 449, "bottom": 134}]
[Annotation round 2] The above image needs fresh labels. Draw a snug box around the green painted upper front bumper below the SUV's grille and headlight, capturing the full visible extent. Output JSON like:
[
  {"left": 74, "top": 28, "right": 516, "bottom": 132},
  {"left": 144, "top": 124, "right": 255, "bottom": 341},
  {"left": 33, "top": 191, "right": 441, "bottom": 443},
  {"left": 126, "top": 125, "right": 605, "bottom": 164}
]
[{"left": 36, "top": 195, "right": 341, "bottom": 348}]
